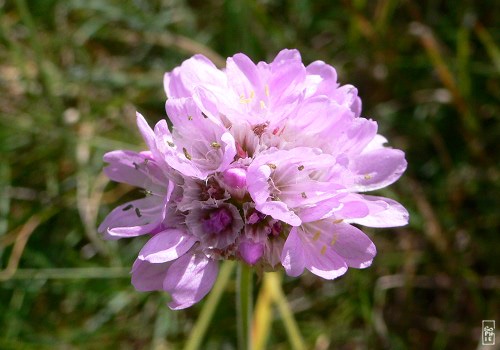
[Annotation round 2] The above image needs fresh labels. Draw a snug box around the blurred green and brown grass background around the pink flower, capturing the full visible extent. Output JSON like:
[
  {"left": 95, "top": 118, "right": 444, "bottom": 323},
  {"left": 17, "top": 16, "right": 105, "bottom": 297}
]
[{"left": 0, "top": 0, "right": 500, "bottom": 349}]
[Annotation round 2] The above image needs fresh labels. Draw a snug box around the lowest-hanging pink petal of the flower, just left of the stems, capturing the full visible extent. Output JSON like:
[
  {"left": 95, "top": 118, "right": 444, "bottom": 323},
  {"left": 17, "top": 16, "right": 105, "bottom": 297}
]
[{"left": 163, "top": 253, "right": 218, "bottom": 310}]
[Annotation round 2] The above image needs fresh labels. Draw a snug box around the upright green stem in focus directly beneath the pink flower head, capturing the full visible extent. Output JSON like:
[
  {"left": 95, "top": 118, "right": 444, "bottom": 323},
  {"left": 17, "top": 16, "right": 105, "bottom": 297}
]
[{"left": 236, "top": 262, "right": 253, "bottom": 350}]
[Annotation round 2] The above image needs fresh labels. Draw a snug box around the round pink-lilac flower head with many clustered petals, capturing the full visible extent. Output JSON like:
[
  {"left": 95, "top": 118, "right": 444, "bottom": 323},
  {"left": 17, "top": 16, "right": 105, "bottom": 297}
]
[{"left": 99, "top": 50, "right": 408, "bottom": 309}]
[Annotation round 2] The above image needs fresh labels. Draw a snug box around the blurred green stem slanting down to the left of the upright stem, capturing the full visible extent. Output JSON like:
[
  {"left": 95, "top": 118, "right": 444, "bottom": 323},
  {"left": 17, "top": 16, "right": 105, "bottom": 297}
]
[{"left": 184, "top": 260, "right": 235, "bottom": 350}]
